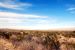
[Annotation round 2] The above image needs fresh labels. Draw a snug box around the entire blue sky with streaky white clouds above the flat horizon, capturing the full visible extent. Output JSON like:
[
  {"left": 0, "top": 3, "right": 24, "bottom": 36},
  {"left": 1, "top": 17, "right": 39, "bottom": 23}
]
[{"left": 0, "top": 0, "right": 75, "bottom": 30}]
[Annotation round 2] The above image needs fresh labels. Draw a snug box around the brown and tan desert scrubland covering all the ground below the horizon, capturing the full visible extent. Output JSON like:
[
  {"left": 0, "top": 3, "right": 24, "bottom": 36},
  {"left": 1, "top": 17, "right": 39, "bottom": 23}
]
[{"left": 0, "top": 30, "right": 75, "bottom": 50}]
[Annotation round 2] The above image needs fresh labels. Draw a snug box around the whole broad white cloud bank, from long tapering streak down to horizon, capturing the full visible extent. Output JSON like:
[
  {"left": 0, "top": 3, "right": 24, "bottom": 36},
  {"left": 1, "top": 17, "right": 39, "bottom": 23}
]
[{"left": 0, "top": 12, "right": 75, "bottom": 30}]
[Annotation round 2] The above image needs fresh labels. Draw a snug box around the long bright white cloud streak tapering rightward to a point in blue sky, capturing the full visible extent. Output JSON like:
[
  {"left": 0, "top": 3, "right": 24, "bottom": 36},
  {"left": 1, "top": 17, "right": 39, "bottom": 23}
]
[{"left": 0, "top": 12, "right": 48, "bottom": 18}]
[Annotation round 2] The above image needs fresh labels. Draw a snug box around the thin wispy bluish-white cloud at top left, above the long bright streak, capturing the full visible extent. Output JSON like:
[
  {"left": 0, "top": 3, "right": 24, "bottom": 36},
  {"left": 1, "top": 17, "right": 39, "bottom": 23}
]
[{"left": 0, "top": 1, "right": 32, "bottom": 10}]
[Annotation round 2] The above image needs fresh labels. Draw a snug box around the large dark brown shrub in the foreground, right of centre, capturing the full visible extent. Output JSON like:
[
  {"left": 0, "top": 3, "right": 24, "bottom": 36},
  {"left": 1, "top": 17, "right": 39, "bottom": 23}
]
[{"left": 43, "top": 34, "right": 60, "bottom": 50}]
